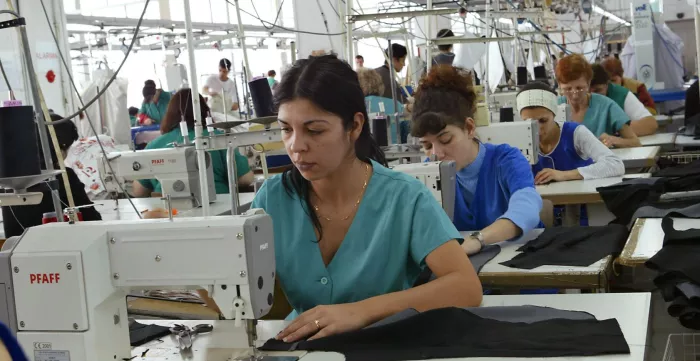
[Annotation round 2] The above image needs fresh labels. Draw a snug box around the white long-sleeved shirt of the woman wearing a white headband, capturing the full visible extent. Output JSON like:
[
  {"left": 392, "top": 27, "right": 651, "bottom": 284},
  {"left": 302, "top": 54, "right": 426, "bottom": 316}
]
[{"left": 545, "top": 122, "right": 625, "bottom": 179}]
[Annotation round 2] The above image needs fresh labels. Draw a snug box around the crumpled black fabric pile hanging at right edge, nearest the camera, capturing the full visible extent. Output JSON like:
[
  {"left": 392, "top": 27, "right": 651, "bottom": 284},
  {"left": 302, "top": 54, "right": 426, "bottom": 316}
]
[{"left": 646, "top": 213, "right": 700, "bottom": 330}]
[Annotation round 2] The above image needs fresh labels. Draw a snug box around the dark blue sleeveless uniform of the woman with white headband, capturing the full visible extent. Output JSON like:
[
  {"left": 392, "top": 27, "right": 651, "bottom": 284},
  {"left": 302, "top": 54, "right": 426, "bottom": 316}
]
[{"left": 532, "top": 122, "right": 593, "bottom": 226}]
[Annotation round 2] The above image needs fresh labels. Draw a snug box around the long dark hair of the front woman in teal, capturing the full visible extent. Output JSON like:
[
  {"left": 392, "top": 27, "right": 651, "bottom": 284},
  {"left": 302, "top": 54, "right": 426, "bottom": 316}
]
[{"left": 275, "top": 55, "right": 386, "bottom": 240}]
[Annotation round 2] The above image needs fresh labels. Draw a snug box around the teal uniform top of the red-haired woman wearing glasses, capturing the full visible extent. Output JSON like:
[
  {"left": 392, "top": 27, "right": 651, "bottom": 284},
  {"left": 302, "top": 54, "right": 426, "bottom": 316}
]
[{"left": 559, "top": 93, "right": 630, "bottom": 137}]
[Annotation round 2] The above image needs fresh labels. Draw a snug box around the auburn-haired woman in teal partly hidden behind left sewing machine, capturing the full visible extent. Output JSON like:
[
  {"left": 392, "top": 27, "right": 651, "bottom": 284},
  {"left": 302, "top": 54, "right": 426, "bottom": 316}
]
[{"left": 132, "top": 89, "right": 254, "bottom": 197}]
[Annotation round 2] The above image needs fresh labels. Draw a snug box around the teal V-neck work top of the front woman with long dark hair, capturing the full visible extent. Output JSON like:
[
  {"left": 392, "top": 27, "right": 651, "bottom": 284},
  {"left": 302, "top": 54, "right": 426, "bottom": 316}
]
[{"left": 251, "top": 162, "right": 462, "bottom": 318}]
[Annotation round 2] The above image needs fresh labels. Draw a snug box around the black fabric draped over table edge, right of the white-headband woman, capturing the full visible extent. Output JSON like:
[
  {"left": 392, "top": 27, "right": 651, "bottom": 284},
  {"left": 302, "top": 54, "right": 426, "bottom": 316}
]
[{"left": 597, "top": 173, "right": 700, "bottom": 225}]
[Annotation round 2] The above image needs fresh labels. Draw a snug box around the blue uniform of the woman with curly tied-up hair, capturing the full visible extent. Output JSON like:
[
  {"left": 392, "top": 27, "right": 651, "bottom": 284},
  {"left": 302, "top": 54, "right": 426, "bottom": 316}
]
[{"left": 454, "top": 143, "right": 542, "bottom": 234}]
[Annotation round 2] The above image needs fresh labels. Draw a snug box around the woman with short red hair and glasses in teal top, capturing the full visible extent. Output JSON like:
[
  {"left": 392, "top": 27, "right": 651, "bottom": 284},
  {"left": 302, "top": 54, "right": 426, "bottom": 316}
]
[{"left": 556, "top": 54, "right": 641, "bottom": 148}]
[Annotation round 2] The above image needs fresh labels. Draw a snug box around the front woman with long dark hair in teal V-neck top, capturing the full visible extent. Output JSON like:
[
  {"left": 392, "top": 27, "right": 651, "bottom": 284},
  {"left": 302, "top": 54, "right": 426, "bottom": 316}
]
[{"left": 252, "top": 55, "right": 482, "bottom": 342}]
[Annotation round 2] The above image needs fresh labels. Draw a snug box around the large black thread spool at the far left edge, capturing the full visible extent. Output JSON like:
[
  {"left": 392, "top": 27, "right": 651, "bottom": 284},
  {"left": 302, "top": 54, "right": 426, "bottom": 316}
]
[{"left": 0, "top": 106, "right": 41, "bottom": 178}]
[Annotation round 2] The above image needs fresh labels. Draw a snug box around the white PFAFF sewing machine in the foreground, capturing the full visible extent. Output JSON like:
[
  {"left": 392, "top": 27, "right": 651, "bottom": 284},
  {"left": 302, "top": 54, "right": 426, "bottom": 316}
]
[{"left": 0, "top": 209, "right": 275, "bottom": 361}]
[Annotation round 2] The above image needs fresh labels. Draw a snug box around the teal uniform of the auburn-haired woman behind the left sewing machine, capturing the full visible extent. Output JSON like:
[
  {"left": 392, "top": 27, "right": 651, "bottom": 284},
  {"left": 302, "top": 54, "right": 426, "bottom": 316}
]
[{"left": 139, "top": 128, "right": 250, "bottom": 194}]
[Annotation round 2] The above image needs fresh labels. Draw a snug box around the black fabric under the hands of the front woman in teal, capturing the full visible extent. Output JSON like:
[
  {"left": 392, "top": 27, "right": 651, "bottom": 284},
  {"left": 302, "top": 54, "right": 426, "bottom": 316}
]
[{"left": 262, "top": 308, "right": 629, "bottom": 361}]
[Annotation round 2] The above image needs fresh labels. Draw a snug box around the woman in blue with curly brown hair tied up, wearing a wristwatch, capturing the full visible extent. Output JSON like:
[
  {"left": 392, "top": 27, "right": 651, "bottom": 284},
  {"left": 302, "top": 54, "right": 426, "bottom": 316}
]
[{"left": 411, "top": 65, "right": 542, "bottom": 254}]
